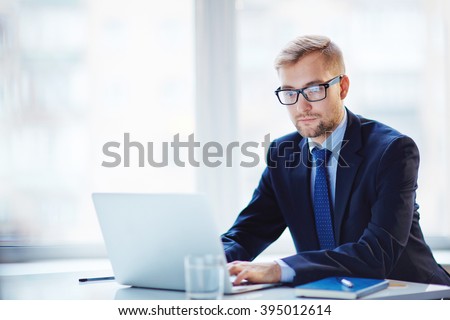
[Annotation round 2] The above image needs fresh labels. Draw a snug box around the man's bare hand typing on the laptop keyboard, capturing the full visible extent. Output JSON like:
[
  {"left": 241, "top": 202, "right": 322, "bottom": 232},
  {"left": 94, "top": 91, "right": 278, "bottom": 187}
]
[{"left": 228, "top": 261, "right": 281, "bottom": 285}]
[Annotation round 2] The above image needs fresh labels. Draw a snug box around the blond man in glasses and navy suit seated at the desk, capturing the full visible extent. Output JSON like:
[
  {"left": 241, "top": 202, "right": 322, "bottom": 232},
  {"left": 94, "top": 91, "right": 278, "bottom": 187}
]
[{"left": 222, "top": 36, "right": 450, "bottom": 285}]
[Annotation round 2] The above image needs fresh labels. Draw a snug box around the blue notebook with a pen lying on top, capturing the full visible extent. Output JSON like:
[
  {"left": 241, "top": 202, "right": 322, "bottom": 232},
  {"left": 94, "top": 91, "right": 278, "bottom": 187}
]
[{"left": 295, "top": 277, "right": 389, "bottom": 299}]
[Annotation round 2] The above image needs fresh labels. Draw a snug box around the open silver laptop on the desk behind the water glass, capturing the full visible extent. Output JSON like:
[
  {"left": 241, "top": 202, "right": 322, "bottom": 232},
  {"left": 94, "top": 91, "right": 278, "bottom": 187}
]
[{"left": 92, "top": 193, "right": 274, "bottom": 294}]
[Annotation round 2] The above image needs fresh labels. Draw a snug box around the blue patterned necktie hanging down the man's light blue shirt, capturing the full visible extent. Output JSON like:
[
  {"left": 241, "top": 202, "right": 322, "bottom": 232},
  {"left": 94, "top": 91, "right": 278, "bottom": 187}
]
[{"left": 312, "top": 148, "right": 335, "bottom": 249}]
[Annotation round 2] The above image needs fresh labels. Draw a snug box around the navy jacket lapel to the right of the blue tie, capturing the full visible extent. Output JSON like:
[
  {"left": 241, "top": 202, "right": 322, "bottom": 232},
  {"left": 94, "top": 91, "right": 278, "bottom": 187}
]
[{"left": 334, "top": 109, "right": 362, "bottom": 245}]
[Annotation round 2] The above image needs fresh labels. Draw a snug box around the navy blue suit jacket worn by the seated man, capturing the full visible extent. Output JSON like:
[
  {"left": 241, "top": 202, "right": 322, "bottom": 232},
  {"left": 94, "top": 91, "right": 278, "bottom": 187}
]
[{"left": 222, "top": 110, "right": 450, "bottom": 285}]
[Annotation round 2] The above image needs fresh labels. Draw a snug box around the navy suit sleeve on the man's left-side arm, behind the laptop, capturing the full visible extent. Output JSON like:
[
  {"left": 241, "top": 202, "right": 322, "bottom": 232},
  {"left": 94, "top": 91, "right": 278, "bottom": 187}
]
[{"left": 222, "top": 142, "right": 286, "bottom": 261}]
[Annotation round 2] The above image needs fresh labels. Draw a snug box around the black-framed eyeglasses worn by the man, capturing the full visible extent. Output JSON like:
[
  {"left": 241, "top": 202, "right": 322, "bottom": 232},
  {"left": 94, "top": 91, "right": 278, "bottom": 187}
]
[{"left": 275, "top": 75, "right": 342, "bottom": 106}]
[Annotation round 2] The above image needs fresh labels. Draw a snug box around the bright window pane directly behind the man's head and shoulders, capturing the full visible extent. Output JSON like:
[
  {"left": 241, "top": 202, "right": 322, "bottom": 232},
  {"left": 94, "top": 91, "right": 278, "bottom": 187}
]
[{"left": 237, "top": 0, "right": 450, "bottom": 250}]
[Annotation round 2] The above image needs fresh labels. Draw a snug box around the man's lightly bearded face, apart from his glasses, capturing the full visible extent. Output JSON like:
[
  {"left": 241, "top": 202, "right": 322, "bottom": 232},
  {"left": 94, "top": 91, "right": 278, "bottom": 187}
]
[{"left": 278, "top": 52, "right": 349, "bottom": 143}]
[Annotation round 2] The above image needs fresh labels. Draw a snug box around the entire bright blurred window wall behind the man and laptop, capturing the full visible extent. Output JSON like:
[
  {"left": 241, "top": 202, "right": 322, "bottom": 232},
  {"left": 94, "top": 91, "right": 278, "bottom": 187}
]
[{"left": 0, "top": 0, "right": 450, "bottom": 261}]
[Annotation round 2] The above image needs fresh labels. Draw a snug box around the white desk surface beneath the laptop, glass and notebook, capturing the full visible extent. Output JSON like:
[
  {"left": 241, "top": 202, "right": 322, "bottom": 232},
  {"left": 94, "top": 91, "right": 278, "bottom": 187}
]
[{"left": 0, "top": 260, "right": 450, "bottom": 300}]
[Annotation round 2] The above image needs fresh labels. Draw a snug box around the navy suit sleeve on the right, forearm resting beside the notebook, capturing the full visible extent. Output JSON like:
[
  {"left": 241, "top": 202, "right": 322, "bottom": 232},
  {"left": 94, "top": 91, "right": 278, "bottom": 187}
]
[{"left": 283, "top": 137, "right": 419, "bottom": 284}]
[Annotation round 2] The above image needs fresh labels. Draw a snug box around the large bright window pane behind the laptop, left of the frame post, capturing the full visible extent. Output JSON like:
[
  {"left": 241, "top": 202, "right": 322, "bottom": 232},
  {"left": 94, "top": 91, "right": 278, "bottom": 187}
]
[{"left": 0, "top": 0, "right": 195, "bottom": 246}]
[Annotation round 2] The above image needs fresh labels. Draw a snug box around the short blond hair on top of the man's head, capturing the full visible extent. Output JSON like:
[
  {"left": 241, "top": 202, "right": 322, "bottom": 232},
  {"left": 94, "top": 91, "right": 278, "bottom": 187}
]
[{"left": 274, "top": 35, "right": 345, "bottom": 73}]
